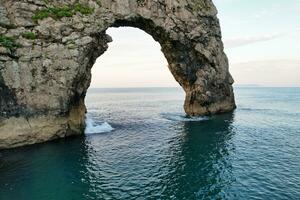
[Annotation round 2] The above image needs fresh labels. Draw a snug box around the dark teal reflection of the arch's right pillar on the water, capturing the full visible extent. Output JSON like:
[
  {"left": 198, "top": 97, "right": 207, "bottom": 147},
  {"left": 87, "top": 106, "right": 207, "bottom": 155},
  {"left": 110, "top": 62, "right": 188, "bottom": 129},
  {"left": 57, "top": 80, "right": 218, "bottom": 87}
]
[{"left": 163, "top": 113, "right": 234, "bottom": 200}]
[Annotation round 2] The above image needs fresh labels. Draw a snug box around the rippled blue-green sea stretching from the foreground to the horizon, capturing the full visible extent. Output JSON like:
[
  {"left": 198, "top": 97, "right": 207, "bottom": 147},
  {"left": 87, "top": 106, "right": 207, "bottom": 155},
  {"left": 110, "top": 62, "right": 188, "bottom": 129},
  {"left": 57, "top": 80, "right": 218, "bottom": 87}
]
[{"left": 0, "top": 88, "right": 300, "bottom": 200}]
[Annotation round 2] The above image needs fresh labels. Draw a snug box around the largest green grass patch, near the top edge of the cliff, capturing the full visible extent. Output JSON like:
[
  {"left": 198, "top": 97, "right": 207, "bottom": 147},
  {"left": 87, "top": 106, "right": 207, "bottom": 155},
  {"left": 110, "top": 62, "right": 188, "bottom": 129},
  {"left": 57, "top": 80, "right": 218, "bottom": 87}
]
[{"left": 32, "top": 3, "right": 94, "bottom": 21}]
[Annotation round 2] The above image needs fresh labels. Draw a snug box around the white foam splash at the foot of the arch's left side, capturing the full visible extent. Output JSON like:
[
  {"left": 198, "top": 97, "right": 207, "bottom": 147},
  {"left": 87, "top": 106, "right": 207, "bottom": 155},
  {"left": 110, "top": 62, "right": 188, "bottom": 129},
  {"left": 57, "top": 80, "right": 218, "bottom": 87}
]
[{"left": 85, "top": 118, "right": 114, "bottom": 135}]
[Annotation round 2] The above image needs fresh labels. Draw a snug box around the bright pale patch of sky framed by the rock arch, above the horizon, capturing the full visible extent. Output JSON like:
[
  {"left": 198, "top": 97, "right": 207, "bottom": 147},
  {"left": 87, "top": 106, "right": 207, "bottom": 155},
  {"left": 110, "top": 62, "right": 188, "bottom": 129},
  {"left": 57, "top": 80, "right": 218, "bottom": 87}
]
[{"left": 89, "top": 27, "right": 179, "bottom": 88}]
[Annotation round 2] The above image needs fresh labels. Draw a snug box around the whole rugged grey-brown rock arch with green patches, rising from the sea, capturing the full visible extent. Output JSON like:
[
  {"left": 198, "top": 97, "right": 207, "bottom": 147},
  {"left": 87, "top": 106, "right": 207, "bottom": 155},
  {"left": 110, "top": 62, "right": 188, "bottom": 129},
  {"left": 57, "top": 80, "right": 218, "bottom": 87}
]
[{"left": 0, "top": 0, "right": 235, "bottom": 148}]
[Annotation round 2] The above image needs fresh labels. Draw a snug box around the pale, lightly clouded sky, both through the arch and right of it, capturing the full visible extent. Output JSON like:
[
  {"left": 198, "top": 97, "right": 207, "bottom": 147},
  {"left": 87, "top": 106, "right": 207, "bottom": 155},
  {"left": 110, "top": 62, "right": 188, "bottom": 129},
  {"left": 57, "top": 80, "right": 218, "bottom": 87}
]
[{"left": 91, "top": 0, "right": 300, "bottom": 88}]
